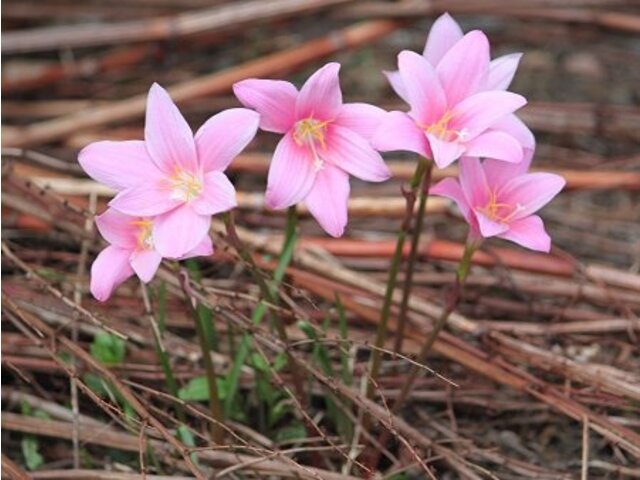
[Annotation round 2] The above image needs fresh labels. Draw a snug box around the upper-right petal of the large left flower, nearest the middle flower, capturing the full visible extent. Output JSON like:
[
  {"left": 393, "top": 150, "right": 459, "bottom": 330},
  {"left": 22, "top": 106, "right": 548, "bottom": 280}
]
[{"left": 195, "top": 108, "right": 260, "bottom": 172}]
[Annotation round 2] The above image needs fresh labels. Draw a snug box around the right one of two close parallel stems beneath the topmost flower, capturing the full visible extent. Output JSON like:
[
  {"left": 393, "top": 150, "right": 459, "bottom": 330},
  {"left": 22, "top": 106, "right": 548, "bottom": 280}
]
[{"left": 393, "top": 160, "right": 433, "bottom": 353}]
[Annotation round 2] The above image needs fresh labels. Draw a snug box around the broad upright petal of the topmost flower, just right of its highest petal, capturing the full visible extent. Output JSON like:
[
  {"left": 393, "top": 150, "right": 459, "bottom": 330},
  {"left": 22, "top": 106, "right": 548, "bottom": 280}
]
[{"left": 436, "top": 30, "right": 490, "bottom": 107}]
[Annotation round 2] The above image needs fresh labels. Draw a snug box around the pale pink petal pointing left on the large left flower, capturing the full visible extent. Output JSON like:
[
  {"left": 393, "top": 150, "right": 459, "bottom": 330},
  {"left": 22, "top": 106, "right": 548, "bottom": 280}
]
[{"left": 78, "top": 140, "right": 158, "bottom": 190}]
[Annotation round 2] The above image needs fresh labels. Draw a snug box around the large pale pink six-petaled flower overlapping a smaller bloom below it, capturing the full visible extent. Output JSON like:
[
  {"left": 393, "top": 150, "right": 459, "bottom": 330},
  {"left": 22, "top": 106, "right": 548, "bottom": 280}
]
[{"left": 78, "top": 84, "right": 259, "bottom": 258}]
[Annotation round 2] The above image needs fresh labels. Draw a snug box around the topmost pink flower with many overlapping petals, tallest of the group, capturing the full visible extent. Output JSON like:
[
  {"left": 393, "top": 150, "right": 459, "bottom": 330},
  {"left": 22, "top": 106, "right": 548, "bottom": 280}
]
[{"left": 373, "top": 15, "right": 535, "bottom": 168}]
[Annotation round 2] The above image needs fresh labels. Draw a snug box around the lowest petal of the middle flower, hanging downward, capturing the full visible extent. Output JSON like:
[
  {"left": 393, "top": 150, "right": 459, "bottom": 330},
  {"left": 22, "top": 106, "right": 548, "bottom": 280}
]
[{"left": 304, "top": 164, "right": 350, "bottom": 237}]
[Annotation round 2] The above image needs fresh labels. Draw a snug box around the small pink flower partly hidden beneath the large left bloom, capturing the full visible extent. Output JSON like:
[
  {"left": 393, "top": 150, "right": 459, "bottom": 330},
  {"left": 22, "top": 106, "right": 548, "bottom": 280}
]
[{"left": 91, "top": 208, "right": 213, "bottom": 302}]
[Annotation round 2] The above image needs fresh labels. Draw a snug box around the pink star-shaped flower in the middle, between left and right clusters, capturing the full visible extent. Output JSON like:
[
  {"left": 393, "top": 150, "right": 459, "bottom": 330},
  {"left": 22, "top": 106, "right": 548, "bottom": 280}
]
[{"left": 233, "top": 63, "right": 391, "bottom": 237}]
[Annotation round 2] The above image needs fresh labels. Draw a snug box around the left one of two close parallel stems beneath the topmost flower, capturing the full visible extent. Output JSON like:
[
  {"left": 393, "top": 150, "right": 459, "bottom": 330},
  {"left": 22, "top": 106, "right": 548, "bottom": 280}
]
[{"left": 367, "top": 158, "right": 427, "bottom": 399}]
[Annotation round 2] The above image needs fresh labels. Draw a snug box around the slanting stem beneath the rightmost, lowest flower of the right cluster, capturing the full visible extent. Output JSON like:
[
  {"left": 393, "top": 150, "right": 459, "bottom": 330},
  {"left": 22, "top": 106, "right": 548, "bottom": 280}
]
[{"left": 368, "top": 239, "right": 479, "bottom": 469}]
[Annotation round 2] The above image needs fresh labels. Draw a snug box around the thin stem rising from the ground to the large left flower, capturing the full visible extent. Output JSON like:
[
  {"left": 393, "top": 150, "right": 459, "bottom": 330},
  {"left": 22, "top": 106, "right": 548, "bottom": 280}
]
[{"left": 181, "top": 268, "right": 224, "bottom": 445}]
